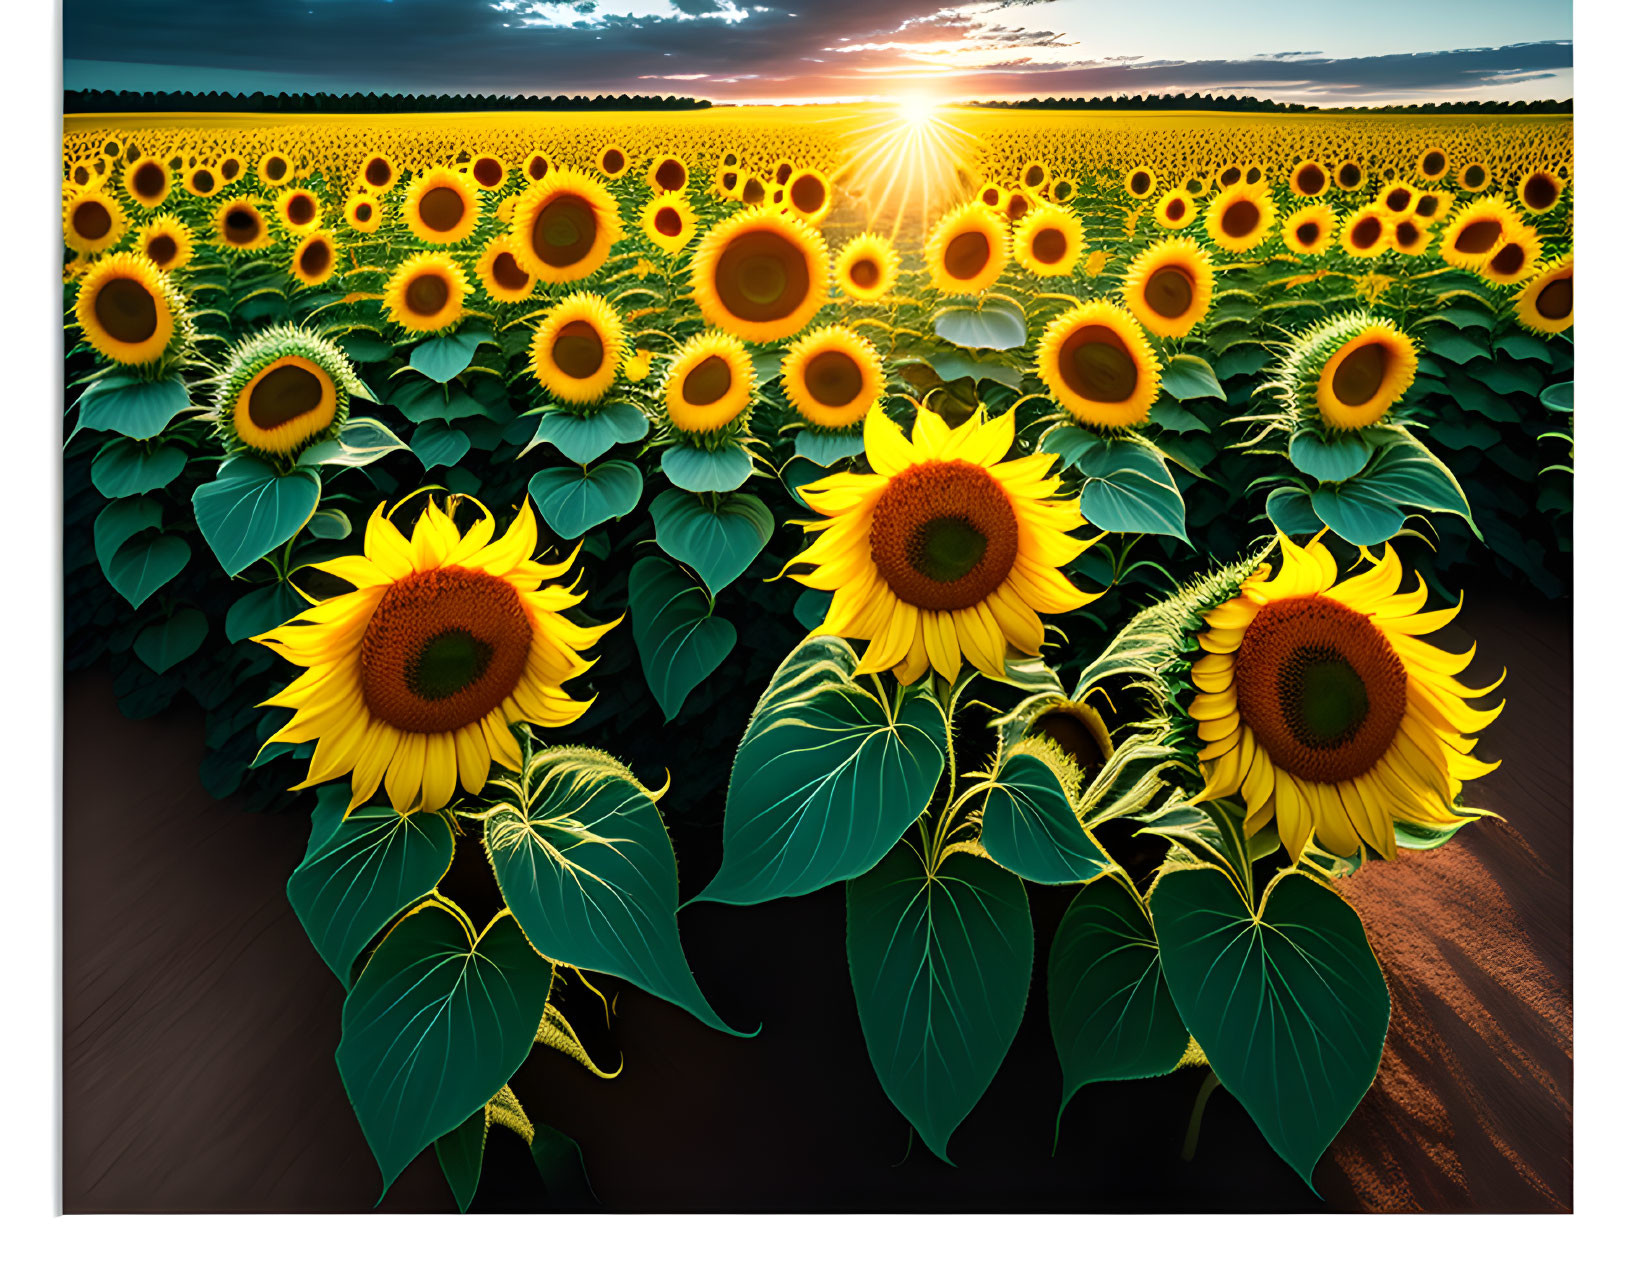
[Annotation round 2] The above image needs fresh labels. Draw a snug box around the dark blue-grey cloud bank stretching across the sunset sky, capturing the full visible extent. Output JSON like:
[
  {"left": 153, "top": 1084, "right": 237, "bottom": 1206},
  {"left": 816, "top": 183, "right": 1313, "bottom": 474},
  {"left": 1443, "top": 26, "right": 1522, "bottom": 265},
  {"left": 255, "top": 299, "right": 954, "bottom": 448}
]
[{"left": 64, "top": 0, "right": 1571, "bottom": 101}]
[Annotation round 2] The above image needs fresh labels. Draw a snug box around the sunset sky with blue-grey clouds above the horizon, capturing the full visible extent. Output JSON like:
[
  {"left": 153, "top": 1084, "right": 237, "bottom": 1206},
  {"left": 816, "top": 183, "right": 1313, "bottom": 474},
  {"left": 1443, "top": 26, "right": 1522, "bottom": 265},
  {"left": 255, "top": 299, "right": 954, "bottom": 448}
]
[{"left": 62, "top": 0, "right": 1573, "bottom": 106}]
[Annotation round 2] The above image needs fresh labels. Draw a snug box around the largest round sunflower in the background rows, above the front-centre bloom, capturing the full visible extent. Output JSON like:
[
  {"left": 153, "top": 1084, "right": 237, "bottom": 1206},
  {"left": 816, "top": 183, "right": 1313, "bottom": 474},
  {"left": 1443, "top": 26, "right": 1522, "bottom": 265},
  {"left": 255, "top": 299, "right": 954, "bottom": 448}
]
[{"left": 692, "top": 209, "right": 829, "bottom": 343}]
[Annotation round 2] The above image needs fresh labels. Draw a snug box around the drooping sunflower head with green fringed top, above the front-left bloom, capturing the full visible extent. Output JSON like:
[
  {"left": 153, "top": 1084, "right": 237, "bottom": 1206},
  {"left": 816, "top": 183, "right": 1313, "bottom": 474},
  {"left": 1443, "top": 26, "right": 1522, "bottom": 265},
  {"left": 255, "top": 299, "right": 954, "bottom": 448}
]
[{"left": 214, "top": 325, "right": 363, "bottom": 461}]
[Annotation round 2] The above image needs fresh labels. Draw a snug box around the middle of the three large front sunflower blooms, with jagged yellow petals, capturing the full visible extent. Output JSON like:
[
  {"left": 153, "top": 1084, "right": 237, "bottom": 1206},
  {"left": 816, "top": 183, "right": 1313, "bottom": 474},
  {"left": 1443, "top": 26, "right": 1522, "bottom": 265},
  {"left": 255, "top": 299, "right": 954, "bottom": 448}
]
[{"left": 790, "top": 405, "right": 1097, "bottom": 683}]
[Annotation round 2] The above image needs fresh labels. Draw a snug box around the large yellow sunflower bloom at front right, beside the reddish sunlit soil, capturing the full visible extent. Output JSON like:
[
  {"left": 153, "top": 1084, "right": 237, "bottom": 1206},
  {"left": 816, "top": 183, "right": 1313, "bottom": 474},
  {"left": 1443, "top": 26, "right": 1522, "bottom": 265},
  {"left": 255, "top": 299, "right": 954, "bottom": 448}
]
[{"left": 1187, "top": 535, "right": 1503, "bottom": 860}]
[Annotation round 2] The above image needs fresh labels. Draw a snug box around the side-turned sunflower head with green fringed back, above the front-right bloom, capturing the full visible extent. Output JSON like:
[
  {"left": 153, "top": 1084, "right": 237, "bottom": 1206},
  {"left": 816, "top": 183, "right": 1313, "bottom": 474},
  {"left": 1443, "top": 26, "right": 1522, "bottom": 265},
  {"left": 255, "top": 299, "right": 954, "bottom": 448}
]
[{"left": 1267, "top": 312, "right": 1419, "bottom": 432}]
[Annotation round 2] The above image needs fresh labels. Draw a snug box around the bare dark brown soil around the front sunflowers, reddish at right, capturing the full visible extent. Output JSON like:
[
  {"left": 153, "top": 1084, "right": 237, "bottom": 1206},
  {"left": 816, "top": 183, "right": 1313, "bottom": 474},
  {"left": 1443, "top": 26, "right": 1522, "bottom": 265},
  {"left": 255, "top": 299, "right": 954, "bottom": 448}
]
[{"left": 62, "top": 593, "right": 1573, "bottom": 1211}]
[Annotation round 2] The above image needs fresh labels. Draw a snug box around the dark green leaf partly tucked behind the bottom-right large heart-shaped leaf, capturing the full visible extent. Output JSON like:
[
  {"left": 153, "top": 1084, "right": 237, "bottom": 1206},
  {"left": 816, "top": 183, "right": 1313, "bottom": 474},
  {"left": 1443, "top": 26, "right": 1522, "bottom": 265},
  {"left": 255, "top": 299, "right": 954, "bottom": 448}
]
[{"left": 1048, "top": 871, "right": 1187, "bottom": 1122}]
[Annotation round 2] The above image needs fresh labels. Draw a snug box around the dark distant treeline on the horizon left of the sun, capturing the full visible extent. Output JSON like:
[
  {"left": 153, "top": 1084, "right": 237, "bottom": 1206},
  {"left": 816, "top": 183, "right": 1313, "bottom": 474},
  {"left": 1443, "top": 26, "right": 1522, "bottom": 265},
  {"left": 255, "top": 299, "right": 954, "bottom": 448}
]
[{"left": 62, "top": 90, "right": 710, "bottom": 116}]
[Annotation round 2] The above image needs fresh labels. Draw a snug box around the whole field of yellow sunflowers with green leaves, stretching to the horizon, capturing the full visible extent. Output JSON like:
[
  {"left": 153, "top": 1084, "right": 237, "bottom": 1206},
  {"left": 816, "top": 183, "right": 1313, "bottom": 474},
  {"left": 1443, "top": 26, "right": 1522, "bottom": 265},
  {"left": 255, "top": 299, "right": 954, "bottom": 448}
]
[{"left": 62, "top": 106, "right": 1573, "bottom": 1208}]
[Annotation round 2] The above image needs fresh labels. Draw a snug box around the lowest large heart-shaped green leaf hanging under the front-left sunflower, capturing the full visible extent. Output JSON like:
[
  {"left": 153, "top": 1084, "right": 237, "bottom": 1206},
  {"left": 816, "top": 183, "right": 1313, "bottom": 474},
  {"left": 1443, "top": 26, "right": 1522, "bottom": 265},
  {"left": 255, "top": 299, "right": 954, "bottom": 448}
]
[{"left": 335, "top": 901, "right": 553, "bottom": 1195}]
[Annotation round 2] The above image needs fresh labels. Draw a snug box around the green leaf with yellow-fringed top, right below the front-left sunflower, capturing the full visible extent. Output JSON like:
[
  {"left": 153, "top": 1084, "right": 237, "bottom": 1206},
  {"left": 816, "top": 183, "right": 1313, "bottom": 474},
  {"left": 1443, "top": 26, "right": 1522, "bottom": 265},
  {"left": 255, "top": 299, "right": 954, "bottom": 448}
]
[{"left": 482, "top": 747, "right": 739, "bottom": 1035}]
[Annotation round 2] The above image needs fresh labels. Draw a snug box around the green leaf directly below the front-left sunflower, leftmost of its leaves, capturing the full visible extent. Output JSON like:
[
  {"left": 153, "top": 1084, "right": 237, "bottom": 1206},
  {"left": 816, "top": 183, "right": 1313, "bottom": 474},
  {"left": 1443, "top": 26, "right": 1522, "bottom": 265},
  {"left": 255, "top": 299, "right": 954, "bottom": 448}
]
[{"left": 284, "top": 791, "right": 455, "bottom": 986}]
